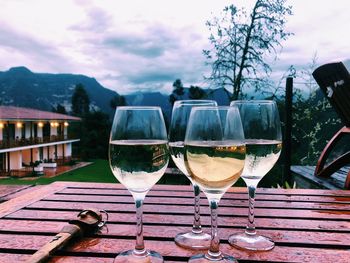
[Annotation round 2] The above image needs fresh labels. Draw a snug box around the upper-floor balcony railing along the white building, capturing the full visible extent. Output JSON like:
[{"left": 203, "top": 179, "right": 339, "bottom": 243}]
[{"left": 0, "top": 135, "right": 77, "bottom": 149}]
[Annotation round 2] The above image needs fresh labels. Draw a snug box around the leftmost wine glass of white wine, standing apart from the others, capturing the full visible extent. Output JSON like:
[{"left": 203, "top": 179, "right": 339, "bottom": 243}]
[{"left": 109, "top": 107, "right": 169, "bottom": 263}]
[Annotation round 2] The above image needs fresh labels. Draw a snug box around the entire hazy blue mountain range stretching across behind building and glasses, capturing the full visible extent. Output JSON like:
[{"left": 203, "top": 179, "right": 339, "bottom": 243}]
[{"left": 0, "top": 67, "right": 231, "bottom": 120}]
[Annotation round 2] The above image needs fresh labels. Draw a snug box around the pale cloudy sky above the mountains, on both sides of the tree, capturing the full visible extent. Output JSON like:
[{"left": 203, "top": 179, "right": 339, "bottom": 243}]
[{"left": 0, "top": 0, "right": 350, "bottom": 94}]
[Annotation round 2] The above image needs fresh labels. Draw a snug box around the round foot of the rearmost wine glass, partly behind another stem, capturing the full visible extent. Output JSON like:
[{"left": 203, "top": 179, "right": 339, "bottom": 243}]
[{"left": 175, "top": 231, "right": 211, "bottom": 250}]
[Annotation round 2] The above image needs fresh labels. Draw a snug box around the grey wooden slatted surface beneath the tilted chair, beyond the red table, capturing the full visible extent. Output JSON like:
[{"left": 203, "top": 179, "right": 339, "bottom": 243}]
[{"left": 291, "top": 165, "right": 350, "bottom": 189}]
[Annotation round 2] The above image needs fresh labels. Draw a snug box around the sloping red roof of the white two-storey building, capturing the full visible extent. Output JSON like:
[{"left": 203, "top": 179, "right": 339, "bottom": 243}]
[{"left": 0, "top": 106, "right": 81, "bottom": 121}]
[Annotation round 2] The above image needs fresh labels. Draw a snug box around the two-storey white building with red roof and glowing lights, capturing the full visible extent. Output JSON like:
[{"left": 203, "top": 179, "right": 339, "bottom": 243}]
[{"left": 0, "top": 106, "right": 81, "bottom": 174}]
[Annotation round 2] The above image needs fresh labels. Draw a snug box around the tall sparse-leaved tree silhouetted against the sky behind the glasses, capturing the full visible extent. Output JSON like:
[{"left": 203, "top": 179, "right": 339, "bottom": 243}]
[{"left": 203, "top": 0, "right": 292, "bottom": 99}]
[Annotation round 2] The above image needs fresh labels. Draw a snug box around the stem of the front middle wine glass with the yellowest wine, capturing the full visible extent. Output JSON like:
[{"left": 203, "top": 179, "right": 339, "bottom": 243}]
[{"left": 206, "top": 200, "right": 221, "bottom": 260}]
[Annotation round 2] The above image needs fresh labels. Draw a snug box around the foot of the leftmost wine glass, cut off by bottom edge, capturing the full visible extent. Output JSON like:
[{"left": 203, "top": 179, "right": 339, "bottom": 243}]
[{"left": 113, "top": 250, "right": 164, "bottom": 263}]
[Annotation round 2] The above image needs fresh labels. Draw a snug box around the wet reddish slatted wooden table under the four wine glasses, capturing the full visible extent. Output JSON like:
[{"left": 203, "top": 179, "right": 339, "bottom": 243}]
[{"left": 0, "top": 182, "right": 350, "bottom": 263}]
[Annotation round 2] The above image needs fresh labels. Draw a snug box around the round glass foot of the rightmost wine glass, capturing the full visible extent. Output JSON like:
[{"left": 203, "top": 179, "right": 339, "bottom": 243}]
[{"left": 228, "top": 233, "right": 275, "bottom": 251}]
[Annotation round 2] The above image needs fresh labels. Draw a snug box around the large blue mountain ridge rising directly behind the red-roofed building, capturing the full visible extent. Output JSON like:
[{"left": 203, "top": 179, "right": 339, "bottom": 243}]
[{"left": 0, "top": 67, "right": 118, "bottom": 114}]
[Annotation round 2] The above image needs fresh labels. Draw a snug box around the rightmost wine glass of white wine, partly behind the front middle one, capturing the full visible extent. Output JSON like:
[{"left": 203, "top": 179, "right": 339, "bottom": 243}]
[{"left": 229, "top": 100, "right": 282, "bottom": 251}]
